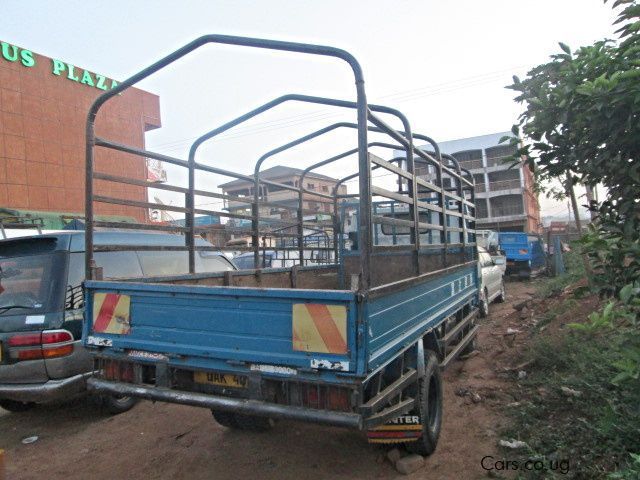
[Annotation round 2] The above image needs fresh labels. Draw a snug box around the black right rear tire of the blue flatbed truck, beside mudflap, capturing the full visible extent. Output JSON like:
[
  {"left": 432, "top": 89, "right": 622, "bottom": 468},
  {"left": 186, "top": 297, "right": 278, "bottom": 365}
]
[{"left": 406, "top": 350, "right": 442, "bottom": 456}]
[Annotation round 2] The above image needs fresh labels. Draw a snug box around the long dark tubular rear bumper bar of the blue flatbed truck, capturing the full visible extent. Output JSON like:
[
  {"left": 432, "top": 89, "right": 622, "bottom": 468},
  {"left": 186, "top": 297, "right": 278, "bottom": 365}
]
[{"left": 87, "top": 377, "right": 364, "bottom": 430}]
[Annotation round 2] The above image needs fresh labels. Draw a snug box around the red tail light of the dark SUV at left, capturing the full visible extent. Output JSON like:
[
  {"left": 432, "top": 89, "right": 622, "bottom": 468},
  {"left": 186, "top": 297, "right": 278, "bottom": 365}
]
[{"left": 7, "top": 330, "right": 73, "bottom": 360}]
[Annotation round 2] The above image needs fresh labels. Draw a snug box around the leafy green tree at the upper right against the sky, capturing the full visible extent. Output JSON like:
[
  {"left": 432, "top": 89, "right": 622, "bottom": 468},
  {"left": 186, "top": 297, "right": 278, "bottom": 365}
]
[{"left": 508, "top": 0, "right": 640, "bottom": 294}]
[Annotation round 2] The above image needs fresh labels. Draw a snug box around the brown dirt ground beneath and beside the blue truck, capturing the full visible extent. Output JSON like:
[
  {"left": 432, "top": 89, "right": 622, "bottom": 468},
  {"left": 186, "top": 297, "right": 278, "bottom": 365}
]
[{"left": 0, "top": 282, "right": 534, "bottom": 480}]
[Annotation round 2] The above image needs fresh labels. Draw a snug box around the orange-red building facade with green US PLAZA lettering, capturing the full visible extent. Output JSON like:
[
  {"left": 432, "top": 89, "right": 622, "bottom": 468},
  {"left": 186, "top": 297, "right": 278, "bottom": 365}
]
[{"left": 0, "top": 41, "right": 161, "bottom": 221}]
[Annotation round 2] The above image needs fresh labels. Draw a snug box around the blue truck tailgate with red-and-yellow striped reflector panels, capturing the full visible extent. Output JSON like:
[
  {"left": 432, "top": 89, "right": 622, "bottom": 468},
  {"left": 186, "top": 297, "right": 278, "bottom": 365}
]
[{"left": 83, "top": 281, "right": 356, "bottom": 371}]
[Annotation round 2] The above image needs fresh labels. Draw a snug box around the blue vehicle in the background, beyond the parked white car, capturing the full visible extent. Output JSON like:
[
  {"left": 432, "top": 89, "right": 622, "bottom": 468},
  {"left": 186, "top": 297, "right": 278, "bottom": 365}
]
[{"left": 500, "top": 232, "right": 546, "bottom": 278}]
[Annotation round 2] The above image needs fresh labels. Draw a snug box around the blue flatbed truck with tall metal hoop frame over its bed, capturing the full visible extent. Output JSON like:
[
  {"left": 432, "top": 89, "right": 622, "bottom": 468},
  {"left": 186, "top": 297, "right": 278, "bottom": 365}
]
[{"left": 83, "top": 35, "right": 478, "bottom": 455}]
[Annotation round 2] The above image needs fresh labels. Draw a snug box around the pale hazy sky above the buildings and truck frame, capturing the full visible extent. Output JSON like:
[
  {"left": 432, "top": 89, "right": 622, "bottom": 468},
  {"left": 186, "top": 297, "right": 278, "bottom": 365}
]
[{"left": 0, "top": 0, "right": 614, "bottom": 219}]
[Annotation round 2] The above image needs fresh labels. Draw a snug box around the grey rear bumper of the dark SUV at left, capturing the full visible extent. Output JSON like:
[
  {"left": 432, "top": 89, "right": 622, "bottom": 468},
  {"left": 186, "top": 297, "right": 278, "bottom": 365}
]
[{"left": 0, "top": 372, "right": 92, "bottom": 403}]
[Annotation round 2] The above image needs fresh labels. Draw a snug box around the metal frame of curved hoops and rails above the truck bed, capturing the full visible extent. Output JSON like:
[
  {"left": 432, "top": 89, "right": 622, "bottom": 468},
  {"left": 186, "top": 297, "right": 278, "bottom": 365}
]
[{"left": 85, "top": 35, "right": 473, "bottom": 294}]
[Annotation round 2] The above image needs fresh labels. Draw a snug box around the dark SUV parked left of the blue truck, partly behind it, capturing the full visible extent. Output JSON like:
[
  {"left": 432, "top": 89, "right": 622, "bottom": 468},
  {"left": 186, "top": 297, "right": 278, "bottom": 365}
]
[{"left": 0, "top": 231, "right": 236, "bottom": 413}]
